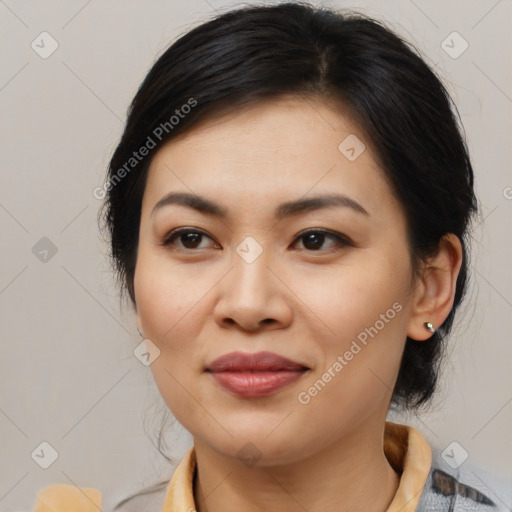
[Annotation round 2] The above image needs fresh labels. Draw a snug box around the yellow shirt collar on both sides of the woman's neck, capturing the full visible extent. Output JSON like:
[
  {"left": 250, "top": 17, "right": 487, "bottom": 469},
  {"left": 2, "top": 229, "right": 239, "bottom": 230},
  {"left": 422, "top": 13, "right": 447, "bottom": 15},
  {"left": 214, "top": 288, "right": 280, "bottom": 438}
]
[{"left": 162, "top": 421, "right": 432, "bottom": 512}]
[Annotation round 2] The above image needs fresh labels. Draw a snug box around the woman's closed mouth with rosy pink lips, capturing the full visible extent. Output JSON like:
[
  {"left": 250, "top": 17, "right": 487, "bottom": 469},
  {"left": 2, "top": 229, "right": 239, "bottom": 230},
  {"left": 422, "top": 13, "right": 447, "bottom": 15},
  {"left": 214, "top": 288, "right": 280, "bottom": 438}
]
[{"left": 206, "top": 352, "right": 310, "bottom": 398}]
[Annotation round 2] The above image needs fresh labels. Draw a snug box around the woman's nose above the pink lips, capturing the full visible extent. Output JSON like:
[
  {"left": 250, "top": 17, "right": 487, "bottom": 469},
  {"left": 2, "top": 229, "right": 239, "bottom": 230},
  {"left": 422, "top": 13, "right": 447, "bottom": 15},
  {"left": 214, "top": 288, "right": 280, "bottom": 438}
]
[{"left": 213, "top": 248, "right": 292, "bottom": 331}]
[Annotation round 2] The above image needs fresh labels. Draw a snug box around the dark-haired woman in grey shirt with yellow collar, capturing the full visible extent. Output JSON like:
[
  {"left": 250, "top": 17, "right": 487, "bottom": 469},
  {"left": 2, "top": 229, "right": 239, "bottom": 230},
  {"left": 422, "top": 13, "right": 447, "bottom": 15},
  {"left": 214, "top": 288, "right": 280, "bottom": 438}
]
[{"left": 32, "top": 3, "right": 505, "bottom": 512}]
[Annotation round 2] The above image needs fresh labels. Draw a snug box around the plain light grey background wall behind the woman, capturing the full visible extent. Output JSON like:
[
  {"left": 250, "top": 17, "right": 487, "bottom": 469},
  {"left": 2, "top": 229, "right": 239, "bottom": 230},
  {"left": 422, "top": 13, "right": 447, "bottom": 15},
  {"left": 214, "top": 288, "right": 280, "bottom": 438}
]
[{"left": 0, "top": 0, "right": 512, "bottom": 512}]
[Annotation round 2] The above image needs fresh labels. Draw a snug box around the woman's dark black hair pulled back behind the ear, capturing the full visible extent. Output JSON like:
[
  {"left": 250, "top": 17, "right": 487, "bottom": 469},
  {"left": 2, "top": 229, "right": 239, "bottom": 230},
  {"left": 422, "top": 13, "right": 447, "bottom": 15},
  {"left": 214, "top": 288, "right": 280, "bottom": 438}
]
[{"left": 100, "top": 2, "right": 477, "bottom": 422}]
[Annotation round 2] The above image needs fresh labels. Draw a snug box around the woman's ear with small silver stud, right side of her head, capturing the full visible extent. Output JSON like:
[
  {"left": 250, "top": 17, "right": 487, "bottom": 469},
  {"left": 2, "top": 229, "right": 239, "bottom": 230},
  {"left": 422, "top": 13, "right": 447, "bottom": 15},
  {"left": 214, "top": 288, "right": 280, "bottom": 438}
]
[{"left": 407, "top": 233, "right": 463, "bottom": 341}]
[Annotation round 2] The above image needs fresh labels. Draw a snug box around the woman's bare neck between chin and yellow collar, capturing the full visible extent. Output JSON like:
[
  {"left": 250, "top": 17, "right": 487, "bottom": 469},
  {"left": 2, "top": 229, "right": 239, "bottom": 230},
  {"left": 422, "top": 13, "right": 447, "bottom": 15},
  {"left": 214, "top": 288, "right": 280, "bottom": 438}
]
[{"left": 194, "top": 420, "right": 400, "bottom": 512}]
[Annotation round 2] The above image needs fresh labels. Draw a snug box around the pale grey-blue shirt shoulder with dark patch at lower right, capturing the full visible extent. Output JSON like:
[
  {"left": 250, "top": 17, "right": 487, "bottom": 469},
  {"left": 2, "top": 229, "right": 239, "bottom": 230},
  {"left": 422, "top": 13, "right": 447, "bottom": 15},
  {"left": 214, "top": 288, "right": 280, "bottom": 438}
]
[{"left": 416, "top": 449, "right": 512, "bottom": 512}]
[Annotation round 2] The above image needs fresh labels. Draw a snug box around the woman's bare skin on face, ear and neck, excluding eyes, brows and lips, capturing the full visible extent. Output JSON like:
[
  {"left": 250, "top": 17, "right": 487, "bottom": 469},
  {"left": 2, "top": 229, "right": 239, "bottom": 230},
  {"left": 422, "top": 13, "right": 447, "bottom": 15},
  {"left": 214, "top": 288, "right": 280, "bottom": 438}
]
[{"left": 134, "top": 97, "right": 461, "bottom": 512}]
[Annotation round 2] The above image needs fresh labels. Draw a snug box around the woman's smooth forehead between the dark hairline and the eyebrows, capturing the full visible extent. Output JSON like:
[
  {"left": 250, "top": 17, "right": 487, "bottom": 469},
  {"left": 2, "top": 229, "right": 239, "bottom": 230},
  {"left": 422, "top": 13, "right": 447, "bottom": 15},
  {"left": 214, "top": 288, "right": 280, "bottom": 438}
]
[{"left": 144, "top": 97, "right": 397, "bottom": 221}]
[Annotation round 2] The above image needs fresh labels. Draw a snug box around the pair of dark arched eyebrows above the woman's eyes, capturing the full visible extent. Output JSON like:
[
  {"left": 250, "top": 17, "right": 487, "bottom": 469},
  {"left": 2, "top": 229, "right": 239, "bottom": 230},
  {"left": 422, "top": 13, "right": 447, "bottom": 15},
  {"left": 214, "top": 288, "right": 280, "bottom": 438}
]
[{"left": 151, "top": 192, "right": 370, "bottom": 220}]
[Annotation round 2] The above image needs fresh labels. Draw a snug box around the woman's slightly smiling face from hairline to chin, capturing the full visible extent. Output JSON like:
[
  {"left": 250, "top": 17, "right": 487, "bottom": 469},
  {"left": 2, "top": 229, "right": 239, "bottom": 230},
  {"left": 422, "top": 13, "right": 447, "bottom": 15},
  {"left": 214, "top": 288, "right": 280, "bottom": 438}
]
[{"left": 134, "top": 97, "right": 413, "bottom": 465}]
